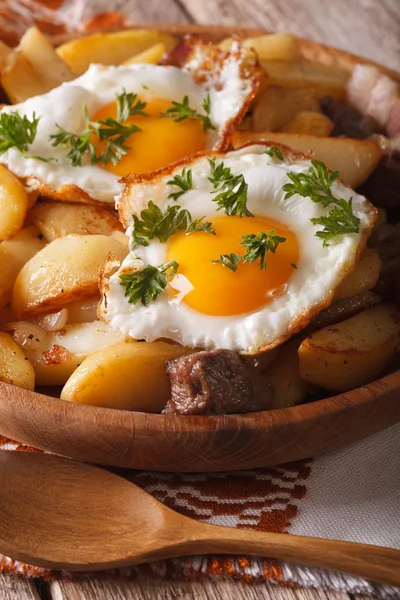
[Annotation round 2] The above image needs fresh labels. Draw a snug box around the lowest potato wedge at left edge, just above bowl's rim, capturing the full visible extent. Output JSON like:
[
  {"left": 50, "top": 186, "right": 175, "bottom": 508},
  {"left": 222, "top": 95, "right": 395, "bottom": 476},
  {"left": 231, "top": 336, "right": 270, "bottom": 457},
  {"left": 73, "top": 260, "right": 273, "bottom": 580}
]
[{"left": 0, "top": 331, "right": 35, "bottom": 390}]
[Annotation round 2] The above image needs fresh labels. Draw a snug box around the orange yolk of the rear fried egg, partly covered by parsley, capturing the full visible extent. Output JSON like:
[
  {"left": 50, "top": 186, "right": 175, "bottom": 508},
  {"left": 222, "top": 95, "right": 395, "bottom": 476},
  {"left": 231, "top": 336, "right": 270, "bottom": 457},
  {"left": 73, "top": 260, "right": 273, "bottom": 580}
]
[{"left": 91, "top": 99, "right": 207, "bottom": 176}]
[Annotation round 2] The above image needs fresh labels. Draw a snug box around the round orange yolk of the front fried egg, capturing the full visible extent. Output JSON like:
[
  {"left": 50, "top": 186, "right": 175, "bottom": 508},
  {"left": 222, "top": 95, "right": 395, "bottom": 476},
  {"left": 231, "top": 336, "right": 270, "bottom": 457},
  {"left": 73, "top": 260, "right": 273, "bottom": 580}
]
[{"left": 168, "top": 217, "right": 299, "bottom": 316}]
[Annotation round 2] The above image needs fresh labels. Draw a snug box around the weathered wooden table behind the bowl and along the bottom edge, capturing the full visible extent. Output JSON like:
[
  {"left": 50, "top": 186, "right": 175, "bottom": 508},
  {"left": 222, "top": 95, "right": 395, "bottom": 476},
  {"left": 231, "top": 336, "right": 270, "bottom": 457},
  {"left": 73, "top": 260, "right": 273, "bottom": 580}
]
[{"left": 0, "top": 0, "right": 400, "bottom": 600}]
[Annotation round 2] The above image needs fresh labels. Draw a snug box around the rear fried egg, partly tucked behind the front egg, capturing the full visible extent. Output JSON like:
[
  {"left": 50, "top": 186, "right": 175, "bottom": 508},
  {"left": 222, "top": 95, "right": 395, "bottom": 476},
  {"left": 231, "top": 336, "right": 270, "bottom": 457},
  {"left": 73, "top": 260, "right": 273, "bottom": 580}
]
[{"left": 0, "top": 42, "right": 259, "bottom": 203}]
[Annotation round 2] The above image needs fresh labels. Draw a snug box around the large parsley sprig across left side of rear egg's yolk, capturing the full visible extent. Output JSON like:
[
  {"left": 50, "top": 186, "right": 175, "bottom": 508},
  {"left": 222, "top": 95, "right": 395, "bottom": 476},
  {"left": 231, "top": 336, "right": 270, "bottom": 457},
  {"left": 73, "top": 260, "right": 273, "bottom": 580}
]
[{"left": 50, "top": 90, "right": 146, "bottom": 167}]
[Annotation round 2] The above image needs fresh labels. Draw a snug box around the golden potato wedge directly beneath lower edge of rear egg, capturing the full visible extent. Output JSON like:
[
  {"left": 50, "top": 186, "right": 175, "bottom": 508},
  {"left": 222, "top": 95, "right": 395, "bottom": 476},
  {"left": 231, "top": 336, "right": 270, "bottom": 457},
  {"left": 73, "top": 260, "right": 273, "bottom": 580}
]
[{"left": 28, "top": 200, "right": 122, "bottom": 242}]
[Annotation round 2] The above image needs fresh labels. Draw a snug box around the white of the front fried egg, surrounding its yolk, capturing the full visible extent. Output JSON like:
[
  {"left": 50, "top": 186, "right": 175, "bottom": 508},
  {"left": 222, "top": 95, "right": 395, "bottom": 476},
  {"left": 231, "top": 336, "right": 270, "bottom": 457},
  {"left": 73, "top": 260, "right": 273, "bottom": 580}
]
[{"left": 101, "top": 146, "right": 376, "bottom": 354}]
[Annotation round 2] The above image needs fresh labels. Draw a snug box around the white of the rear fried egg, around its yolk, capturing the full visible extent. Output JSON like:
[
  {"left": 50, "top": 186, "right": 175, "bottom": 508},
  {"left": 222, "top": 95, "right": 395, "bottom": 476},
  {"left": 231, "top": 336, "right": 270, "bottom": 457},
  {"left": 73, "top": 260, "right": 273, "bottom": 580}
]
[{"left": 0, "top": 44, "right": 254, "bottom": 203}]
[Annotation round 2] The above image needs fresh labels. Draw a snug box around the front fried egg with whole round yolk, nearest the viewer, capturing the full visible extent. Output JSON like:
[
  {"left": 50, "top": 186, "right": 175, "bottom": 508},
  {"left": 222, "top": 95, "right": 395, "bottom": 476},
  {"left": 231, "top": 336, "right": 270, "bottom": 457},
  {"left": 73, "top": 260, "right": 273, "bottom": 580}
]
[{"left": 101, "top": 145, "right": 376, "bottom": 354}]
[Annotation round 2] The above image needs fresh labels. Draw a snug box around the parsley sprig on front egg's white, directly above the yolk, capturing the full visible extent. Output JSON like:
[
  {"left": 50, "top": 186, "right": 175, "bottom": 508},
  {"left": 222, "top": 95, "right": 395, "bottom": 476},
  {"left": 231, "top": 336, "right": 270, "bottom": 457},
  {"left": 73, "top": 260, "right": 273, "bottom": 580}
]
[{"left": 208, "top": 158, "right": 254, "bottom": 217}]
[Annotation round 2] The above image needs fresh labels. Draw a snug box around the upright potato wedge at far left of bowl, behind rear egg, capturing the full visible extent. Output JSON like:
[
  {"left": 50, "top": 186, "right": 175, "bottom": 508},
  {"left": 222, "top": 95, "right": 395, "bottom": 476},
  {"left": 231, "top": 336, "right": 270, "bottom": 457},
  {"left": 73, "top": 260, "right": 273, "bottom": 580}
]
[{"left": 18, "top": 27, "right": 75, "bottom": 91}]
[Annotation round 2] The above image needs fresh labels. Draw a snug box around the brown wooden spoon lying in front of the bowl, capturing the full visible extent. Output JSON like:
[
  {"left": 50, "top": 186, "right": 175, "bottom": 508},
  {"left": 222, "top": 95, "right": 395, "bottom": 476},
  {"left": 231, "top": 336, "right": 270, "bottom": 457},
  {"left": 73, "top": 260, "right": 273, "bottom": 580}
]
[{"left": 0, "top": 451, "right": 400, "bottom": 585}]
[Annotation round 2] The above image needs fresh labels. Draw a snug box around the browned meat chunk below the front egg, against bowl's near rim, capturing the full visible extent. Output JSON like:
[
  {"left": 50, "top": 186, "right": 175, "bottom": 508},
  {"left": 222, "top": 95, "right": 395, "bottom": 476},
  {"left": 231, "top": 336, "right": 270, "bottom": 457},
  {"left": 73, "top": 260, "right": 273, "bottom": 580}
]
[{"left": 163, "top": 350, "right": 273, "bottom": 415}]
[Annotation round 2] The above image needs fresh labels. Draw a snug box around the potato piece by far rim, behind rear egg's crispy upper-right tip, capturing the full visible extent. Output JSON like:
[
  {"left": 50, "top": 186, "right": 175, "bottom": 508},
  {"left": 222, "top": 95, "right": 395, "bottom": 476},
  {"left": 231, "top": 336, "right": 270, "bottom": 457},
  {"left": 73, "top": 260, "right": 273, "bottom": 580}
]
[{"left": 218, "top": 33, "right": 299, "bottom": 61}]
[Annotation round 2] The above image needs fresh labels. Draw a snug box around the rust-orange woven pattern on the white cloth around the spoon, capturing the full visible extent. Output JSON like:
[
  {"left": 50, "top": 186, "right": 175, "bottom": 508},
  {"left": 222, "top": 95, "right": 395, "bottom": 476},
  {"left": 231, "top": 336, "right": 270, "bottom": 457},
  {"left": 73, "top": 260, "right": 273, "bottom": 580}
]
[{"left": 0, "top": 436, "right": 312, "bottom": 582}]
